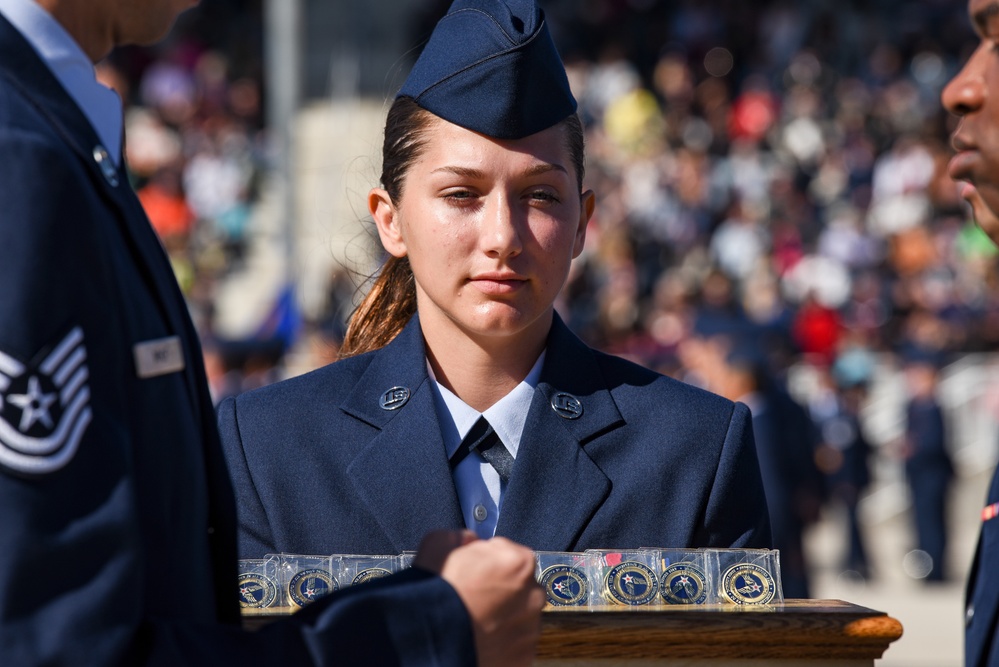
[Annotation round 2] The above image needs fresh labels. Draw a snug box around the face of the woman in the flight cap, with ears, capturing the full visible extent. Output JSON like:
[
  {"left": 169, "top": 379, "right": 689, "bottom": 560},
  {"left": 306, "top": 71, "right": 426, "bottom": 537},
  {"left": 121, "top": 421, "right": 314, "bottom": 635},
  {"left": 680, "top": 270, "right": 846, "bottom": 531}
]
[{"left": 368, "top": 119, "right": 594, "bottom": 352}]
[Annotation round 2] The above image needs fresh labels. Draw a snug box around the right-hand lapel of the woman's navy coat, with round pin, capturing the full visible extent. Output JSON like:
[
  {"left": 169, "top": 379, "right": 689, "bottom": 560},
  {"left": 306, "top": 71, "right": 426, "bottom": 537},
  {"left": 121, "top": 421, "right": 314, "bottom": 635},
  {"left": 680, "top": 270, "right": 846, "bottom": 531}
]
[{"left": 496, "top": 315, "right": 623, "bottom": 551}]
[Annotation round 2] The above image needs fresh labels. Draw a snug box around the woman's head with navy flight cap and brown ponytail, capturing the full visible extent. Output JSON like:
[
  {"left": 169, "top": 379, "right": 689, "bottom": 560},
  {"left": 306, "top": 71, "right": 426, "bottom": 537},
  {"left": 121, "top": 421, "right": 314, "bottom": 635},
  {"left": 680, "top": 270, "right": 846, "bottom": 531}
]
[{"left": 341, "top": 0, "right": 594, "bottom": 356}]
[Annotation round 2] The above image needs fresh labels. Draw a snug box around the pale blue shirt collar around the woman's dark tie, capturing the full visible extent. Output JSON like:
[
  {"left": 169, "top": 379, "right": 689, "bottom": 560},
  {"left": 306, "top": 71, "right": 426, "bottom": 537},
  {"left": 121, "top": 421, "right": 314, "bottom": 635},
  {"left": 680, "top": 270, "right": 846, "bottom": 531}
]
[{"left": 427, "top": 351, "right": 545, "bottom": 459}]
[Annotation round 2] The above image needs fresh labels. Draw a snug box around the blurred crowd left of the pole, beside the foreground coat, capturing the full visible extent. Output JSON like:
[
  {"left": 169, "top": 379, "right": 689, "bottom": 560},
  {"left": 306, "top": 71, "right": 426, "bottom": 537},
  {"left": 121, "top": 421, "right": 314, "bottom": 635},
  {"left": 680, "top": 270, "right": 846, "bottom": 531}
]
[{"left": 97, "top": 0, "right": 268, "bottom": 354}]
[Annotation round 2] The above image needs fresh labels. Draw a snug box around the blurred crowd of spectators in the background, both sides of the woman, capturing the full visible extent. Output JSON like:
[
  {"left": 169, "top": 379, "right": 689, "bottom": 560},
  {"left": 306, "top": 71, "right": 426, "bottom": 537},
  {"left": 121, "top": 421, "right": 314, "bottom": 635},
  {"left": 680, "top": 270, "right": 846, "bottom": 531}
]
[{"left": 101, "top": 0, "right": 999, "bottom": 597}]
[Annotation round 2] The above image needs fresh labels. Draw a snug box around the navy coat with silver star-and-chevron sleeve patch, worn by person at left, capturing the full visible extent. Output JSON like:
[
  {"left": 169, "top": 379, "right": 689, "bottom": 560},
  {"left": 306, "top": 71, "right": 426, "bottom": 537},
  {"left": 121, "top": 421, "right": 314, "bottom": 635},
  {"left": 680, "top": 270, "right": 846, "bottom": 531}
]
[{"left": 0, "top": 16, "right": 474, "bottom": 667}]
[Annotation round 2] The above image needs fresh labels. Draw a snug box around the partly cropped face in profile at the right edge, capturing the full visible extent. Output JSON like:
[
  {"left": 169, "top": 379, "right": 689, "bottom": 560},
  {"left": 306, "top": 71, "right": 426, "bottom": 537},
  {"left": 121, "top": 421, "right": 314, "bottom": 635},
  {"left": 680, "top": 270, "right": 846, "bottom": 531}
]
[{"left": 942, "top": 0, "right": 999, "bottom": 241}]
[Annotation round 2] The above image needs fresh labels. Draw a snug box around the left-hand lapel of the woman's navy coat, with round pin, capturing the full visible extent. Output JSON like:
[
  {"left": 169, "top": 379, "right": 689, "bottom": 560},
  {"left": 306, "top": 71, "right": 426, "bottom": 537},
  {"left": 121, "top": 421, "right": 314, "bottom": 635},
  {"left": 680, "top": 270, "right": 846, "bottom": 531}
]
[{"left": 341, "top": 316, "right": 464, "bottom": 551}]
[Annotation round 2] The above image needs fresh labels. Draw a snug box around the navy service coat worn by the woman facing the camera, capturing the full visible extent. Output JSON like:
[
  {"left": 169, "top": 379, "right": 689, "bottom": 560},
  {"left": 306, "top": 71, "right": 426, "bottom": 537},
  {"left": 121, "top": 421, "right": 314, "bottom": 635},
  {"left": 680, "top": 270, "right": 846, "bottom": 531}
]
[{"left": 219, "top": 316, "right": 770, "bottom": 557}]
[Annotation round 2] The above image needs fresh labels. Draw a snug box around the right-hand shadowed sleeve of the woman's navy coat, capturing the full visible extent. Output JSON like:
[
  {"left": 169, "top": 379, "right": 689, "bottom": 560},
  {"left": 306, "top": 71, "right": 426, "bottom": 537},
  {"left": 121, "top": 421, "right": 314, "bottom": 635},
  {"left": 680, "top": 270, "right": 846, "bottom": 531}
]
[{"left": 703, "top": 403, "right": 773, "bottom": 549}]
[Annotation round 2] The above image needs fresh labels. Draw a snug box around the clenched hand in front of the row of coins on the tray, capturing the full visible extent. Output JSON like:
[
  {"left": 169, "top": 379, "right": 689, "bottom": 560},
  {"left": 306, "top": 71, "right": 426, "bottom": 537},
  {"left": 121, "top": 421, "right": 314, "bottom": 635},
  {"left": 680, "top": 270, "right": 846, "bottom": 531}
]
[{"left": 441, "top": 537, "right": 545, "bottom": 667}]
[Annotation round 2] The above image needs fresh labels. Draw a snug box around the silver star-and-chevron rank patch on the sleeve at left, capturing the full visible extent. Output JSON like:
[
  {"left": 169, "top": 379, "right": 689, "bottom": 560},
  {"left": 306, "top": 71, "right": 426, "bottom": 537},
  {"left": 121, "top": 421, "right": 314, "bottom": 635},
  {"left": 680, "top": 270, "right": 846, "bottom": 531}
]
[{"left": 0, "top": 327, "right": 92, "bottom": 475}]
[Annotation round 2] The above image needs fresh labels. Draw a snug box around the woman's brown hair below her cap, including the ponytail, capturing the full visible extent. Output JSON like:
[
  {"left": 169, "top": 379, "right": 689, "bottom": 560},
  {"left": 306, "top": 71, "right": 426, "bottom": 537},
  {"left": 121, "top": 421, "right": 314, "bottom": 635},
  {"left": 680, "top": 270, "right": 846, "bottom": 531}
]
[{"left": 340, "top": 97, "right": 585, "bottom": 359}]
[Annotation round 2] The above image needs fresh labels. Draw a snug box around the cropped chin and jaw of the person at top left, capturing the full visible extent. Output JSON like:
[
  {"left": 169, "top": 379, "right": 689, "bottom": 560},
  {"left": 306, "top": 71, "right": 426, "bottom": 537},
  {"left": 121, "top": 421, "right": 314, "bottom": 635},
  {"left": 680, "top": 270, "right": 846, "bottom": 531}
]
[{"left": 37, "top": 0, "right": 198, "bottom": 62}]
